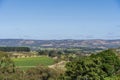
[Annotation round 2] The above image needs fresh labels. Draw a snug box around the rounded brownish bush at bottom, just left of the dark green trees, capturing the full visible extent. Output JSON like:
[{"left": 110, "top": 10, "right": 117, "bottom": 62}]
[{"left": 26, "top": 66, "right": 58, "bottom": 80}]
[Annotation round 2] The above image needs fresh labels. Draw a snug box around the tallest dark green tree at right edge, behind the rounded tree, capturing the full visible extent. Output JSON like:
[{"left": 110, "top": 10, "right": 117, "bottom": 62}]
[{"left": 91, "top": 49, "right": 120, "bottom": 76}]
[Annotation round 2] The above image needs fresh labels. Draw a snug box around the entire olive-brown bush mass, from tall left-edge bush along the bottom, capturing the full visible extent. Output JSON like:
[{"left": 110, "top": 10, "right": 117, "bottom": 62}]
[{"left": 0, "top": 52, "right": 58, "bottom": 80}]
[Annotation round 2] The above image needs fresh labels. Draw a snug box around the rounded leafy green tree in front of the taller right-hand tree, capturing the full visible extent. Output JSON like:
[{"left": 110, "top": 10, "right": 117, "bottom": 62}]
[{"left": 60, "top": 57, "right": 105, "bottom": 80}]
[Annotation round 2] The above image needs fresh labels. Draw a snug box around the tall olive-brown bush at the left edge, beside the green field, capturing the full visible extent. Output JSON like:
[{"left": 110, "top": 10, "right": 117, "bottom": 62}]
[{"left": 0, "top": 52, "right": 16, "bottom": 80}]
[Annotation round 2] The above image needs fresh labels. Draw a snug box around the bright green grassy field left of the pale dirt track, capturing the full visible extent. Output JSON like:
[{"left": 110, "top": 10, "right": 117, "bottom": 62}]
[{"left": 12, "top": 56, "right": 54, "bottom": 69}]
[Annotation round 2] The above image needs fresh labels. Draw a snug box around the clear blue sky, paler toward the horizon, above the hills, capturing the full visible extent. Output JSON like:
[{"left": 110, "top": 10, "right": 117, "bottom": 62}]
[{"left": 0, "top": 0, "right": 120, "bottom": 40}]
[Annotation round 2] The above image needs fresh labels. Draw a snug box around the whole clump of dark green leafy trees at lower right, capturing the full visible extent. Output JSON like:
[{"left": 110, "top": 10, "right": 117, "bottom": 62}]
[{"left": 60, "top": 50, "right": 120, "bottom": 80}]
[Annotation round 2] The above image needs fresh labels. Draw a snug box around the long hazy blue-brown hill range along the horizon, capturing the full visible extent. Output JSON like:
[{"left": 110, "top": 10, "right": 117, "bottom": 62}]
[{"left": 0, "top": 39, "right": 120, "bottom": 49}]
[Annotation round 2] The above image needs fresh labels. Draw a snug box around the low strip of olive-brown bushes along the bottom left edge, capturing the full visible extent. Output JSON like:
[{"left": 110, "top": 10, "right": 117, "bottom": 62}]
[{"left": 0, "top": 66, "right": 59, "bottom": 80}]
